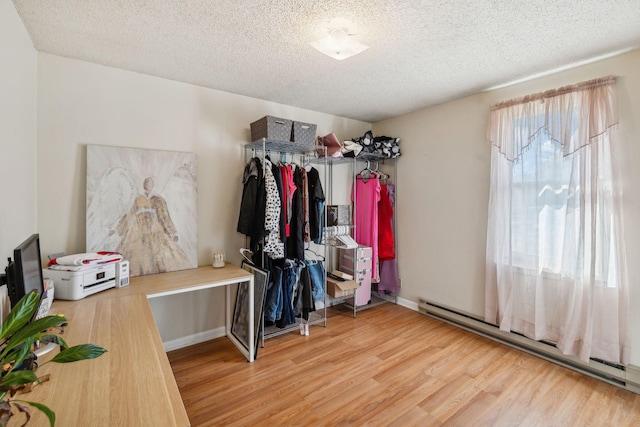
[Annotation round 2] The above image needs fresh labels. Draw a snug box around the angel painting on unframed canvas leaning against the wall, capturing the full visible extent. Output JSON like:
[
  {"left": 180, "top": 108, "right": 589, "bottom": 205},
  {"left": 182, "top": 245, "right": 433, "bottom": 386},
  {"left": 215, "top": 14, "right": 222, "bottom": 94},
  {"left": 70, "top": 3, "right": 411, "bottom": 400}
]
[{"left": 86, "top": 145, "right": 198, "bottom": 276}]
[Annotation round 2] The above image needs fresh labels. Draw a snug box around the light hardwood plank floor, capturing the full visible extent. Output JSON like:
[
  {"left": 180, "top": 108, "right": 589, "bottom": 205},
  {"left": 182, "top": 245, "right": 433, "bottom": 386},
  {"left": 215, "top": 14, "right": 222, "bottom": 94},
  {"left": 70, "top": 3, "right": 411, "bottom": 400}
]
[{"left": 168, "top": 304, "right": 640, "bottom": 427}]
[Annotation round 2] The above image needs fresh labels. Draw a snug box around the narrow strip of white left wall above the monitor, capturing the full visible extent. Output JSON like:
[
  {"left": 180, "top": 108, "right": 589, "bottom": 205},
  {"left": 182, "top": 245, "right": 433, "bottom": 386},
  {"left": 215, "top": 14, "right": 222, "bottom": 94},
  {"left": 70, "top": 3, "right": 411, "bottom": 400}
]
[{"left": 0, "top": 0, "right": 38, "bottom": 260}]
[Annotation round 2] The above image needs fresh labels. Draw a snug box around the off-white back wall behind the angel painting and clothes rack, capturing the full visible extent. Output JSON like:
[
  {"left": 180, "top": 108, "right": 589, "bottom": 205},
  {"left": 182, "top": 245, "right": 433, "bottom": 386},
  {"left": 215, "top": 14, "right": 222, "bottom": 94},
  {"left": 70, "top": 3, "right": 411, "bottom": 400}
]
[{"left": 38, "top": 53, "right": 371, "bottom": 341}]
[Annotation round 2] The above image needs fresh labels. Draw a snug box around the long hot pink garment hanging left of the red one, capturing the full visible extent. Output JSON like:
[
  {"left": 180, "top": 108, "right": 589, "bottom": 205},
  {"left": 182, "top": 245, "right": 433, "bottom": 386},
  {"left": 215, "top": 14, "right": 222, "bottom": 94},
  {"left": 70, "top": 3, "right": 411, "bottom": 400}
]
[{"left": 351, "top": 174, "right": 380, "bottom": 282}]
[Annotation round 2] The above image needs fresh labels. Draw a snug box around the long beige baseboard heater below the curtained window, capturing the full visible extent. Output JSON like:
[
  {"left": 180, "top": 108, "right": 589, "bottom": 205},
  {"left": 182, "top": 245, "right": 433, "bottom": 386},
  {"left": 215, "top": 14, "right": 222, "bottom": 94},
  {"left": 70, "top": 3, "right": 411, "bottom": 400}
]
[{"left": 418, "top": 298, "right": 640, "bottom": 394}]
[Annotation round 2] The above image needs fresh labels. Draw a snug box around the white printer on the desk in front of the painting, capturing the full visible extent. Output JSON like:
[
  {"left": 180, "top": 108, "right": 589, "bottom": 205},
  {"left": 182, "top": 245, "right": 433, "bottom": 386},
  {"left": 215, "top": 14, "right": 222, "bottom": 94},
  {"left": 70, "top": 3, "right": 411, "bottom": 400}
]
[{"left": 42, "top": 262, "right": 119, "bottom": 300}]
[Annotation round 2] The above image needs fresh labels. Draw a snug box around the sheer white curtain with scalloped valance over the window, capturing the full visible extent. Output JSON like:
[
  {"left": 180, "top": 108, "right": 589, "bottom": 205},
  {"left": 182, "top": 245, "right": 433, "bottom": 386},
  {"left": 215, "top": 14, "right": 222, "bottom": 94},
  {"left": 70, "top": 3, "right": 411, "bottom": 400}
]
[{"left": 485, "top": 77, "right": 630, "bottom": 364}]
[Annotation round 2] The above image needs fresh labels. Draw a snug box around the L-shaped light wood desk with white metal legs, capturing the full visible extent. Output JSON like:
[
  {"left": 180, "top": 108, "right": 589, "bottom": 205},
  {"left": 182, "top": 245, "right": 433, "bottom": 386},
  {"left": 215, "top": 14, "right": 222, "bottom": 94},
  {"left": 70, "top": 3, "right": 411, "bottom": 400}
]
[{"left": 10, "top": 264, "right": 255, "bottom": 426}]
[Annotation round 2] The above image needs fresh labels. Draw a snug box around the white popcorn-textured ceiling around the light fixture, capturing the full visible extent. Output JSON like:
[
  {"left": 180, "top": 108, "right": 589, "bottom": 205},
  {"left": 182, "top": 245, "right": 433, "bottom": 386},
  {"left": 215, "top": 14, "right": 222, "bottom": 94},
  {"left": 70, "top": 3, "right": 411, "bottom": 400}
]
[{"left": 13, "top": 0, "right": 640, "bottom": 122}]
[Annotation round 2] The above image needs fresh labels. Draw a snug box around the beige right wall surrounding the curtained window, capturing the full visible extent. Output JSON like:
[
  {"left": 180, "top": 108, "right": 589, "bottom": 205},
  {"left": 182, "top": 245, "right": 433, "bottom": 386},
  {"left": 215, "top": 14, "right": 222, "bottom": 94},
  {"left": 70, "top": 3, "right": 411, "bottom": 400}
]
[{"left": 373, "top": 51, "right": 640, "bottom": 365}]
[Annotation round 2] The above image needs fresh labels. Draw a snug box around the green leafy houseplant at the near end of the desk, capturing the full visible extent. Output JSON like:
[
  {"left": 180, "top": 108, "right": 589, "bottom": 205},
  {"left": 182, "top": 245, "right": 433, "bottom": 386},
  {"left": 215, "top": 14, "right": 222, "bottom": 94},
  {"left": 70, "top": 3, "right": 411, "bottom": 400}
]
[{"left": 0, "top": 292, "right": 106, "bottom": 427}]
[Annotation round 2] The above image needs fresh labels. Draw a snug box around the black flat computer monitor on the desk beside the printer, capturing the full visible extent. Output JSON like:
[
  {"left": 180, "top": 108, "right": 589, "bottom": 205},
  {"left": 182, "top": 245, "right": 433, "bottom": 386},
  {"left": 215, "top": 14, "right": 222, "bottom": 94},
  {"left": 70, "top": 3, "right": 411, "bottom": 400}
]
[{"left": 5, "top": 233, "right": 44, "bottom": 308}]
